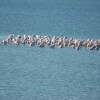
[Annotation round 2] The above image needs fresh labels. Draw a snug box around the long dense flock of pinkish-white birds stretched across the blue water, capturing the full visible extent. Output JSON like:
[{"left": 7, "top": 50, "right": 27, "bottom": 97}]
[{"left": 0, "top": 34, "right": 100, "bottom": 50}]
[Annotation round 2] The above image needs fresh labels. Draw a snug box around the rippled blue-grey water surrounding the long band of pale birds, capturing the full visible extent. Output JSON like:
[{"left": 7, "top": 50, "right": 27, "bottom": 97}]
[{"left": 0, "top": 0, "right": 100, "bottom": 100}]
